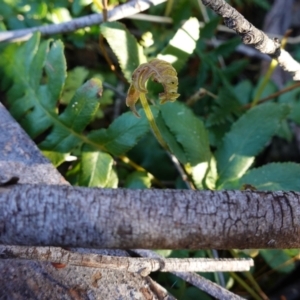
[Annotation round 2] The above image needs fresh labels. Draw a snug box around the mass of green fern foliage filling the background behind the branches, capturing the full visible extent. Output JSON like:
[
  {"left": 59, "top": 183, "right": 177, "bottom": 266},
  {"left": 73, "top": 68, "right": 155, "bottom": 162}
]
[{"left": 0, "top": 0, "right": 300, "bottom": 299}]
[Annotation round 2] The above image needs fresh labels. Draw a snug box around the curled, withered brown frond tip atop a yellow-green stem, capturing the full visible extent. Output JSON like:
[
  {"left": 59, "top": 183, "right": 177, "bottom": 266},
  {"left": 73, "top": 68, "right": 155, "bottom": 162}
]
[{"left": 126, "top": 59, "right": 180, "bottom": 116}]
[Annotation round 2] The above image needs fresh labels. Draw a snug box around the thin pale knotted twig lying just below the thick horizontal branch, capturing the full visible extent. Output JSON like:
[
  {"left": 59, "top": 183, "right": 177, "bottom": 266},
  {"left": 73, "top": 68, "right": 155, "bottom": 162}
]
[{"left": 0, "top": 245, "right": 253, "bottom": 276}]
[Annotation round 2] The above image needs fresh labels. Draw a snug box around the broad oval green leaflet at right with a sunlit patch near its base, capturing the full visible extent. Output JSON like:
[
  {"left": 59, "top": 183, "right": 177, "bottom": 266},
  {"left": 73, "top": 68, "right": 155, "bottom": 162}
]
[{"left": 216, "top": 103, "right": 289, "bottom": 188}]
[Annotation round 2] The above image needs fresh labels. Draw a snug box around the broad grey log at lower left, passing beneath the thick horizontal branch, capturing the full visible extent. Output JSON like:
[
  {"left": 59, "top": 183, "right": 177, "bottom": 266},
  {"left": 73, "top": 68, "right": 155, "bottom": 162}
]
[{"left": 0, "top": 103, "right": 166, "bottom": 300}]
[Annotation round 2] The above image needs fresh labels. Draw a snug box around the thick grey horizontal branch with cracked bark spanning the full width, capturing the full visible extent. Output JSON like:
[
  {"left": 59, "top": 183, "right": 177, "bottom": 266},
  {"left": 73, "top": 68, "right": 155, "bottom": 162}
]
[{"left": 0, "top": 185, "right": 300, "bottom": 249}]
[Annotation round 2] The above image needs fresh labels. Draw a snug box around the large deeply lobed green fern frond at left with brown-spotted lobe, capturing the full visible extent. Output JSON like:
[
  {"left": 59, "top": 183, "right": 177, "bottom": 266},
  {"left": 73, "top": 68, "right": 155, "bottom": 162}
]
[{"left": 0, "top": 33, "right": 149, "bottom": 175}]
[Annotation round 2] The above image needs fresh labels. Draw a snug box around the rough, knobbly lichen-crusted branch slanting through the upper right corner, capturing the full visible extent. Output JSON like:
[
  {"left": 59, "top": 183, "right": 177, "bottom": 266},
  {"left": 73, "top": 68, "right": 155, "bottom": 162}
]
[{"left": 202, "top": 0, "right": 300, "bottom": 80}]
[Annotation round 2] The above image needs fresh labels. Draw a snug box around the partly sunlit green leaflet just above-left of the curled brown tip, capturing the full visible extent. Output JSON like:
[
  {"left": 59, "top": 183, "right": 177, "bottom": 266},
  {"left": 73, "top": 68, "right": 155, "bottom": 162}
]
[{"left": 100, "top": 22, "right": 147, "bottom": 82}]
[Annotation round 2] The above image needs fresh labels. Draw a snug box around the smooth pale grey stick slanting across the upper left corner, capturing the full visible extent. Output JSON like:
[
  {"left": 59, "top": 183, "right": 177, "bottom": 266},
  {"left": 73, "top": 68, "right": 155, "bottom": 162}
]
[{"left": 0, "top": 0, "right": 166, "bottom": 42}]
